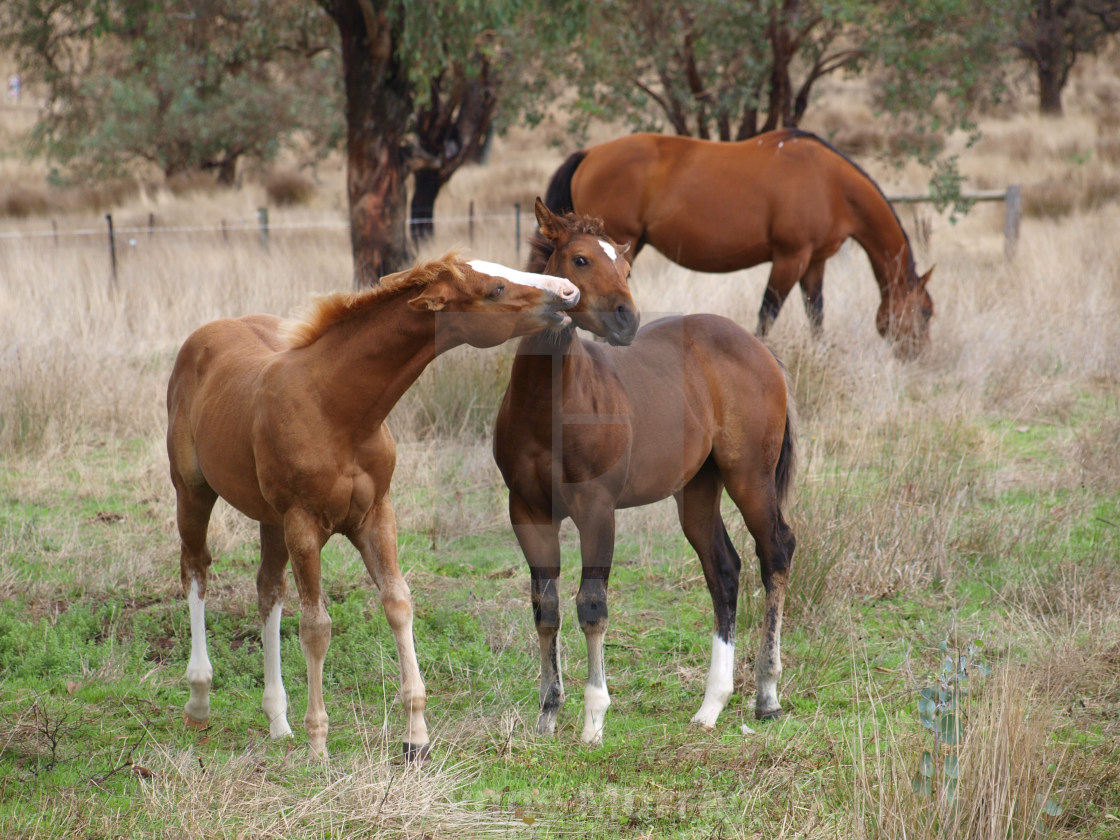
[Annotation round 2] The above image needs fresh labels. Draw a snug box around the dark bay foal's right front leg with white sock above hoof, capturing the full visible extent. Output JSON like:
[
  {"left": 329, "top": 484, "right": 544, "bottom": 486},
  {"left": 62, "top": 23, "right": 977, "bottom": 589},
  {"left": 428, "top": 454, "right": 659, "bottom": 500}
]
[{"left": 573, "top": 500, "right": 615, "bottom": 744}]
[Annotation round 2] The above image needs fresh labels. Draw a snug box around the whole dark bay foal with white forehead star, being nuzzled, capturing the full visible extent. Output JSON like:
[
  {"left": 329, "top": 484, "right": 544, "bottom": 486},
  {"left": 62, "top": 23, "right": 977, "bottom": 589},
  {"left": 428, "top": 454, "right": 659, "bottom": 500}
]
[{"left": 494, "top": 203, "right": 794, "bottom": 744}]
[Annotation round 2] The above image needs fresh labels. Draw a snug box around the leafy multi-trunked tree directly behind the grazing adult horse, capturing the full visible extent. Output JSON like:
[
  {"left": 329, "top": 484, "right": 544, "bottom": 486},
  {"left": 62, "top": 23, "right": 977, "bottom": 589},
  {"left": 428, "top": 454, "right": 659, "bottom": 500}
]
[{"left": 568, "top": 0, "right": 1009, "bottom": 209}]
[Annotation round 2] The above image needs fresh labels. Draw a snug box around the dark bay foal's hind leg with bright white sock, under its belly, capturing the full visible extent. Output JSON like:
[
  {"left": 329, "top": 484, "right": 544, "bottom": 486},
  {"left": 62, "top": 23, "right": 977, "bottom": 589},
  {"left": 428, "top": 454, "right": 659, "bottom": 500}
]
[{"left": 675, "top": 463, "right": 741, "bottom": 729}]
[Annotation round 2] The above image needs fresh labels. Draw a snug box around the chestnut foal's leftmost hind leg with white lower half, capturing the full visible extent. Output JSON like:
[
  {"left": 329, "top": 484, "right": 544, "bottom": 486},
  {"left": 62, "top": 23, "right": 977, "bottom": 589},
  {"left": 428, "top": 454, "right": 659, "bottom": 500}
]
[{"left": 171, "top": 479, "right": 217, "bottom": 728}]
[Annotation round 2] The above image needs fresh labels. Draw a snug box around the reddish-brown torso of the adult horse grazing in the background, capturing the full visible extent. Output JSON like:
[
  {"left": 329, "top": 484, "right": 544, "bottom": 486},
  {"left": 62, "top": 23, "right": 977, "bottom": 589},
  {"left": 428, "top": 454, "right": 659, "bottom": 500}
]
[{"left": 571, "top": 130, "right": 859, "bottom": 271}]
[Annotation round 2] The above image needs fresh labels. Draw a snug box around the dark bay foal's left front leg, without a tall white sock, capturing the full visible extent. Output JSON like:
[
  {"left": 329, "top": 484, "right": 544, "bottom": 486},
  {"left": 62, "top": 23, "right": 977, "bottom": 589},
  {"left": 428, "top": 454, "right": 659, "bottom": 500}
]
[{"left": 510, "top": 492, "right": 563, "bottom": 735}]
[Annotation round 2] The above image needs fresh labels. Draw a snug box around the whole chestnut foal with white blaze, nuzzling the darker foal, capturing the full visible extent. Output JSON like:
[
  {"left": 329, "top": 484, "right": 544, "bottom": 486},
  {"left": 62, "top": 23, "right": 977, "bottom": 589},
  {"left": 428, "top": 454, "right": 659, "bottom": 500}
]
[{"left": 167, "top": 255, "right": 579, "bottom": 757}]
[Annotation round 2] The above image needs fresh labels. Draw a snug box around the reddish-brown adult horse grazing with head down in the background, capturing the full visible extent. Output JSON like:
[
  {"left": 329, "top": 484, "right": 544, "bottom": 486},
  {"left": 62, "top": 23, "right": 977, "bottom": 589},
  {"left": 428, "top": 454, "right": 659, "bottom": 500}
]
[{"left": 545, "top": 129, "right": 933, "bottom": 358}]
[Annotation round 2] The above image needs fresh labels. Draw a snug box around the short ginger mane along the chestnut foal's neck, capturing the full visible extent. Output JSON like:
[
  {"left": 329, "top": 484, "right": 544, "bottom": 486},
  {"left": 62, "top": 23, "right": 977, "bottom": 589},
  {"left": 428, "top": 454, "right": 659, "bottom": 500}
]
[{"left": 282, "top": 253, "right": 463, "bottom": 348}]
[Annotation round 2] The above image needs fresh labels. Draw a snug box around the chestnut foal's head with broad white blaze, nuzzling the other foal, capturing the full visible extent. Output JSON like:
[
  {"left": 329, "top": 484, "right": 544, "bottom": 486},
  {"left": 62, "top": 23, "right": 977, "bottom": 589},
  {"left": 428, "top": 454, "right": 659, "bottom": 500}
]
[{"left": 400, "top": 254, "right": 579, "bottom": 347}]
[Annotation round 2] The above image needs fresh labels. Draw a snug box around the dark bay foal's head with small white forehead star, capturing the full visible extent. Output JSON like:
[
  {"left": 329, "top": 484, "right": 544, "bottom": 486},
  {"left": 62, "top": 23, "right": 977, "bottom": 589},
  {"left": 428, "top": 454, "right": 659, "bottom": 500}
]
[{"left": 529, "top": 198, "right": 640, "bottom": 344}]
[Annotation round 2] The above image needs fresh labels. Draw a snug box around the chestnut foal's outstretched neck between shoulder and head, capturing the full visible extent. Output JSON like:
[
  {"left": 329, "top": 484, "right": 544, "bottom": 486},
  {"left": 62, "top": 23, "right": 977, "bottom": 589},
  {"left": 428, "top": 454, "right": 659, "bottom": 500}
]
[{"left": 299, "top": 293, "right": 447, "bottom": 432}]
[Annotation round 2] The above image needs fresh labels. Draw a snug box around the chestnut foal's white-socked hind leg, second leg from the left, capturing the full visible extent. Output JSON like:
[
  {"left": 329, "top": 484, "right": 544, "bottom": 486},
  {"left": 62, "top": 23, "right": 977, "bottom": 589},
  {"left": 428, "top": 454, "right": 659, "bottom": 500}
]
[{"left": 256, "top": 522, "right": 291, "bottom": 738}]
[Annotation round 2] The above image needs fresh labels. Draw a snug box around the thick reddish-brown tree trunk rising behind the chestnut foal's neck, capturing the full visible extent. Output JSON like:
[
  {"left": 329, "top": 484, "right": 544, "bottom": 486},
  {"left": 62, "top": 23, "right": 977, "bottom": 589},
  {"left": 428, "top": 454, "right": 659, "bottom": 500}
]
[{"left": 333, "top": 0, "right": 412, "bottom": 288}]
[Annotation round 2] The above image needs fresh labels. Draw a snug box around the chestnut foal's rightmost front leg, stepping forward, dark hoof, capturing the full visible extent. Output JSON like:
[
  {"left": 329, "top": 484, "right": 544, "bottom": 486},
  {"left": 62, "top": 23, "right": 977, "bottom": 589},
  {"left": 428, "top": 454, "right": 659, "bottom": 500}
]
[{"left": 349, "top": 496, "right": 430, "bottom": 760}]
